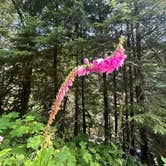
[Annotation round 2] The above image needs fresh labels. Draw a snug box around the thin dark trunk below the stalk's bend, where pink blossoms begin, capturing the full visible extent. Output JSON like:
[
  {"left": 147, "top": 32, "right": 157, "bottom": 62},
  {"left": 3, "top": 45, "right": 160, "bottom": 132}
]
[{"left": 81, "top": 77, "right": 86, "bottom": 134}]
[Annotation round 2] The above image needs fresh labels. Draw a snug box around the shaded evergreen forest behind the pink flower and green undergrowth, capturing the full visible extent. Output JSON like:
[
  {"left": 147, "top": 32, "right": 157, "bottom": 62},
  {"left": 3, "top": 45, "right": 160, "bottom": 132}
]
[{"left": 0, "top": 0, "right": 166, "bottom": 165}]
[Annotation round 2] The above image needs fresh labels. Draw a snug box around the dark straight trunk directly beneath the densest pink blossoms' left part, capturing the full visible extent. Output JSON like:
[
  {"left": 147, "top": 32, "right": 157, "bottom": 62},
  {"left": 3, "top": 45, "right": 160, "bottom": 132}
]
[{"left": 103, "top": 73, "right": 109, "bottom": 143}]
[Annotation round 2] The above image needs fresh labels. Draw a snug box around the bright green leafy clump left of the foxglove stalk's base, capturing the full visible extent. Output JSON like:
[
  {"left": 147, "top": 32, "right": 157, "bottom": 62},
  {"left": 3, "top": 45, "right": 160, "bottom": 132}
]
[{"left": 0, "top": 112, "right": 44, "bottom": 166}]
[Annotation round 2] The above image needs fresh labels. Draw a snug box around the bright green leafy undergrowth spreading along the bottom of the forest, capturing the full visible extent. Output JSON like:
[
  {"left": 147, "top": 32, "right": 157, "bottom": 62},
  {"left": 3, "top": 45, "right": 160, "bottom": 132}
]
[{"left": 0, "top": 112, "right": 138, "bottom": 166}]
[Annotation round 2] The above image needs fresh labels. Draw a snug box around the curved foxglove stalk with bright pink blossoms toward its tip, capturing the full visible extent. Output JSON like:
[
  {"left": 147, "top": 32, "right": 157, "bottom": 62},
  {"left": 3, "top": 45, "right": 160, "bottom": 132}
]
[{"left": 44, "top": 44, "right": 126, "bottom": 147}]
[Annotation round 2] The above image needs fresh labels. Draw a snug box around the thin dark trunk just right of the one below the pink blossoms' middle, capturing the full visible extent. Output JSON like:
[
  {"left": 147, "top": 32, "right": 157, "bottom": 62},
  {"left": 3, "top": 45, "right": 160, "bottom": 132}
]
[{"left": 113, "top": 71, "right": 118, "bottom": 141}]
